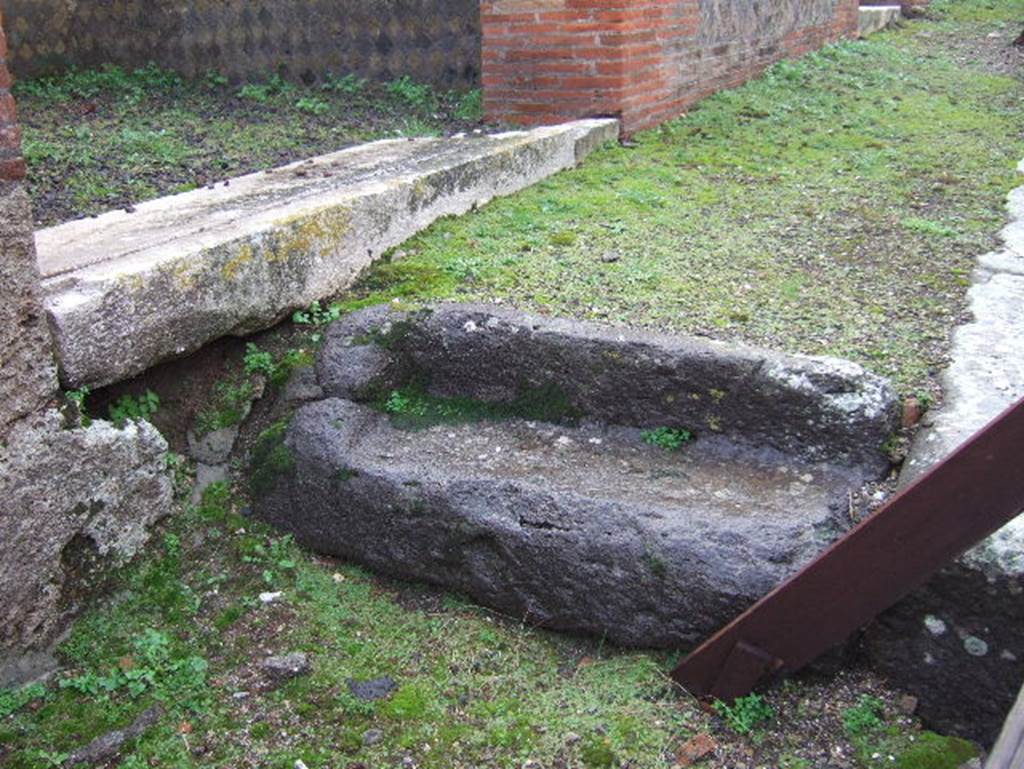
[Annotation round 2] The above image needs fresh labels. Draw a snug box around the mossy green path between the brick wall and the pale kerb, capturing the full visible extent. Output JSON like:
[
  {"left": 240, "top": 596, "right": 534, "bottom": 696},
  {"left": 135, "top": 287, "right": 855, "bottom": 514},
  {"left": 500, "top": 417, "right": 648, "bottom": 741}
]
[{"left": 337, "top": 0, "right": 1024, "bottom": 393}]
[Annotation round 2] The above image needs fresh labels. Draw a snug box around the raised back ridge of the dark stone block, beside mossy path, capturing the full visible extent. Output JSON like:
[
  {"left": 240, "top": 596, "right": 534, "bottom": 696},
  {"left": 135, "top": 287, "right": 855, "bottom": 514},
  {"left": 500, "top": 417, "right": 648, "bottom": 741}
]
[{"left": 318, "top": 304, "right": 898, "bottom": 472}]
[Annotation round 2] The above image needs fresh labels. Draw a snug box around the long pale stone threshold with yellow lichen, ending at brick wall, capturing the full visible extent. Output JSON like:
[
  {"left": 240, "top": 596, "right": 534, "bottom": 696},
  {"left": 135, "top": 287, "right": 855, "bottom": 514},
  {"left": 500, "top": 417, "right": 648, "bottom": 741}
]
[{"left": 36, "top": 120, "right": 618, "bottom": 387}]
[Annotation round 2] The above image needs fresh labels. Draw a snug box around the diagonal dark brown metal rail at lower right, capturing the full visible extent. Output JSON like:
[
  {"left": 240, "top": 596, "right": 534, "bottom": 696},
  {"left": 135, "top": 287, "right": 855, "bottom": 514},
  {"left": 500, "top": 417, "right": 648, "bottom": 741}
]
[{"left": 672, "top": 400, "right": 1024, "bottom": 699}]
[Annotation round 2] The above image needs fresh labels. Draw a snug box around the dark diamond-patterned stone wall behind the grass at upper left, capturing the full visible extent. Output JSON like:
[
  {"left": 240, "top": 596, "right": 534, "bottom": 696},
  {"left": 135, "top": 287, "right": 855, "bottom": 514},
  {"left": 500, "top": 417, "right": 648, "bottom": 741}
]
[{"left": 2, "top": 0, "right": 480, "bottom": 88}]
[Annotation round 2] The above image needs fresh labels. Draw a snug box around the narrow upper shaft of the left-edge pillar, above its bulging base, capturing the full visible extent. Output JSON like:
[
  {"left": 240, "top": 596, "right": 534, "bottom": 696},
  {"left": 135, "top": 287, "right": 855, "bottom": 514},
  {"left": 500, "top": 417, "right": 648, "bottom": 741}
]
[{"left": 0, "top": 9, "right": 57, "bottom": 439}]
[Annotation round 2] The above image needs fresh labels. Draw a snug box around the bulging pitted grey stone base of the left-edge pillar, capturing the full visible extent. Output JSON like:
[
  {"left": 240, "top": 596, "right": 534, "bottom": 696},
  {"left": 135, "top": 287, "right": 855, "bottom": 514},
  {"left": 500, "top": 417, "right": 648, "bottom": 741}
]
[{"left": 0, "top": 411, "right": 172, "bottom": 686}]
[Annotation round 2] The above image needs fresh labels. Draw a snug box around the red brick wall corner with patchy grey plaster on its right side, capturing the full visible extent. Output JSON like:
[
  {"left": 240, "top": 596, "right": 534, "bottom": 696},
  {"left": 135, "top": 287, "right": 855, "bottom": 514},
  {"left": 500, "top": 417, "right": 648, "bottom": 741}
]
[{"left": 480, "top": 0, "right": 858, "bottom": 133}]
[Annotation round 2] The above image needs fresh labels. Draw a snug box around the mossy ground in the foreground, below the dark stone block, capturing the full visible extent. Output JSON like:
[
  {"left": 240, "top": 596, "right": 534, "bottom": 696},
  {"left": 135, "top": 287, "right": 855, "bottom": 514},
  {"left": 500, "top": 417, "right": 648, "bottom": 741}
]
[{"left": 0, "top": 484, "right": 971, "bottom": 769}]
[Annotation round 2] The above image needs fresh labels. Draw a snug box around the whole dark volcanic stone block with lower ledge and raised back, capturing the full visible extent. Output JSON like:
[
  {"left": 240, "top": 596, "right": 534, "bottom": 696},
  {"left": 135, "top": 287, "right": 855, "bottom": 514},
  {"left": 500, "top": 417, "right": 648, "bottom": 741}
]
[{"left": 252, "top": 305, "right": 898, "bottom": 646}]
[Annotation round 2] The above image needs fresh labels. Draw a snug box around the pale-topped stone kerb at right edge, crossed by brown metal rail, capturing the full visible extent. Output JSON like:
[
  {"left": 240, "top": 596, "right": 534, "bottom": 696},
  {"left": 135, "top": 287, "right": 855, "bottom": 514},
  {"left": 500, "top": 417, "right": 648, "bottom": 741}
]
[{"left": 864, "top": 161, "right": 1024, "bottom": 743}]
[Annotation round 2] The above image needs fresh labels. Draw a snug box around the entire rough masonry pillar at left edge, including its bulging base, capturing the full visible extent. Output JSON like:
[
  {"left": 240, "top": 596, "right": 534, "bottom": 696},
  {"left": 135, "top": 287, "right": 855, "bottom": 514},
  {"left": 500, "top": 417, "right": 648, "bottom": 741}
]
[{"left": 0, "top": 14, "right": 172, "bottom": 687}]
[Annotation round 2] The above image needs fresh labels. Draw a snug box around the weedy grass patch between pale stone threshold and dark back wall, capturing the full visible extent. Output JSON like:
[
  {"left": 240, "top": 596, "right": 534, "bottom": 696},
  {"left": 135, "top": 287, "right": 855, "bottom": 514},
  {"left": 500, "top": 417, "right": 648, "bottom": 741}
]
[{"left": 14, "top": 65, "right": 480, "bottom": 225}]
